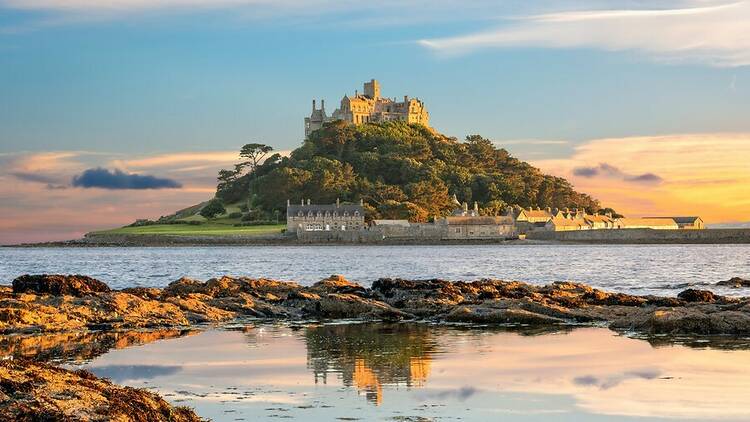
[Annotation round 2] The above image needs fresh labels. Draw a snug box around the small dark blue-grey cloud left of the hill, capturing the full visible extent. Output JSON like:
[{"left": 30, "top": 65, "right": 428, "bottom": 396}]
[{"left": 72, "top": 167, "right": 182, "bottom": 189}]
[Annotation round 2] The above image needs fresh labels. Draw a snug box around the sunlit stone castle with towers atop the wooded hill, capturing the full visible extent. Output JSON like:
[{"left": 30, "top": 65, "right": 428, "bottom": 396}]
[{"left": 305, "top": 79, "right": 430, "bottom": 138}]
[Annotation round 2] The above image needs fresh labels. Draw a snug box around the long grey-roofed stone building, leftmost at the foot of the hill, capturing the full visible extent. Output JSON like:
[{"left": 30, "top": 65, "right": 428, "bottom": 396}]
[{"left": 286, "top": 199, "right": 365, "bottom": 233}]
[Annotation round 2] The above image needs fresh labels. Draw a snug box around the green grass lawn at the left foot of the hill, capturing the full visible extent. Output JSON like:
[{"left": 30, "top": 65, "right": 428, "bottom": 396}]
[{"left": 91, "top": 223, "right": 286, "bottom": 236}]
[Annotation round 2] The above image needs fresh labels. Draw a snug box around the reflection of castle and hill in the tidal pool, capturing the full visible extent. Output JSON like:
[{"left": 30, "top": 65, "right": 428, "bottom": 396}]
[{"left": 304, "top": 323, "right": 439, "bottom": 405}]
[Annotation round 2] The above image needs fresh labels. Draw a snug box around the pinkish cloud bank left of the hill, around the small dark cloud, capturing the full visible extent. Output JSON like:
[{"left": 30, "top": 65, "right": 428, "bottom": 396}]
[{"left": 0, "top": 151, "right": 250, "bottom": 244}]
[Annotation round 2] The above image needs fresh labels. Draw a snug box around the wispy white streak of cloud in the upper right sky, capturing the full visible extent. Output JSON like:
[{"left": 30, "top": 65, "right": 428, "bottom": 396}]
[{"left": 418, "top": 0, "right": 750, "bottom": 67}]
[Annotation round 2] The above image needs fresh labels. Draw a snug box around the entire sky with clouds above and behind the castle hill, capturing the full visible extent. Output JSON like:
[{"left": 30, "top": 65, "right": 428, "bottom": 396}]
[{"left": 0, "top": 0, "right": 750, "bottom": 243}]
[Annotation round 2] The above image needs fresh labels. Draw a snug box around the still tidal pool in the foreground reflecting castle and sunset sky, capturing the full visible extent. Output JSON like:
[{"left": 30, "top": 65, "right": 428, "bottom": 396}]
[{"left": 8, "top": 323, "right": 750, "bottom": 421}]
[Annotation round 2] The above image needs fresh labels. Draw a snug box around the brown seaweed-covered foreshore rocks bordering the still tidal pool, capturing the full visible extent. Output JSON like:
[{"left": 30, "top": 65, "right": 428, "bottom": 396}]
[{"left": 0, "top": 275, "right": 750, "bottom": 421}]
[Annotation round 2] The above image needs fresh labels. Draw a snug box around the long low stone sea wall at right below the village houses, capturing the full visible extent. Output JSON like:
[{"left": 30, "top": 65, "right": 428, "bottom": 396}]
[{"left": 526, "top": 229, "right": 750, "bottom": 244}]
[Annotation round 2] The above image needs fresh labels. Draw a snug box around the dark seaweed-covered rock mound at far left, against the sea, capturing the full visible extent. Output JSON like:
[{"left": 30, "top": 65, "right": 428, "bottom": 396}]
[{"left": 13, "top": 274, "right": 110, "bottom": 297}]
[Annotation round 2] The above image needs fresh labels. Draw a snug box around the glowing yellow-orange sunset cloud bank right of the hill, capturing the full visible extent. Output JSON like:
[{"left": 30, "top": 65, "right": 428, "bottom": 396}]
[{"left": 534, "top": 134, "right": 750, "bottom": 223}]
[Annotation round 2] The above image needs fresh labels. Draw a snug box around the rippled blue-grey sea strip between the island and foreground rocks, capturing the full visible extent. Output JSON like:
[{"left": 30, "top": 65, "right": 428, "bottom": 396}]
[{"left": 0, "top": 245, "right": 750, "bottom": 295}]
